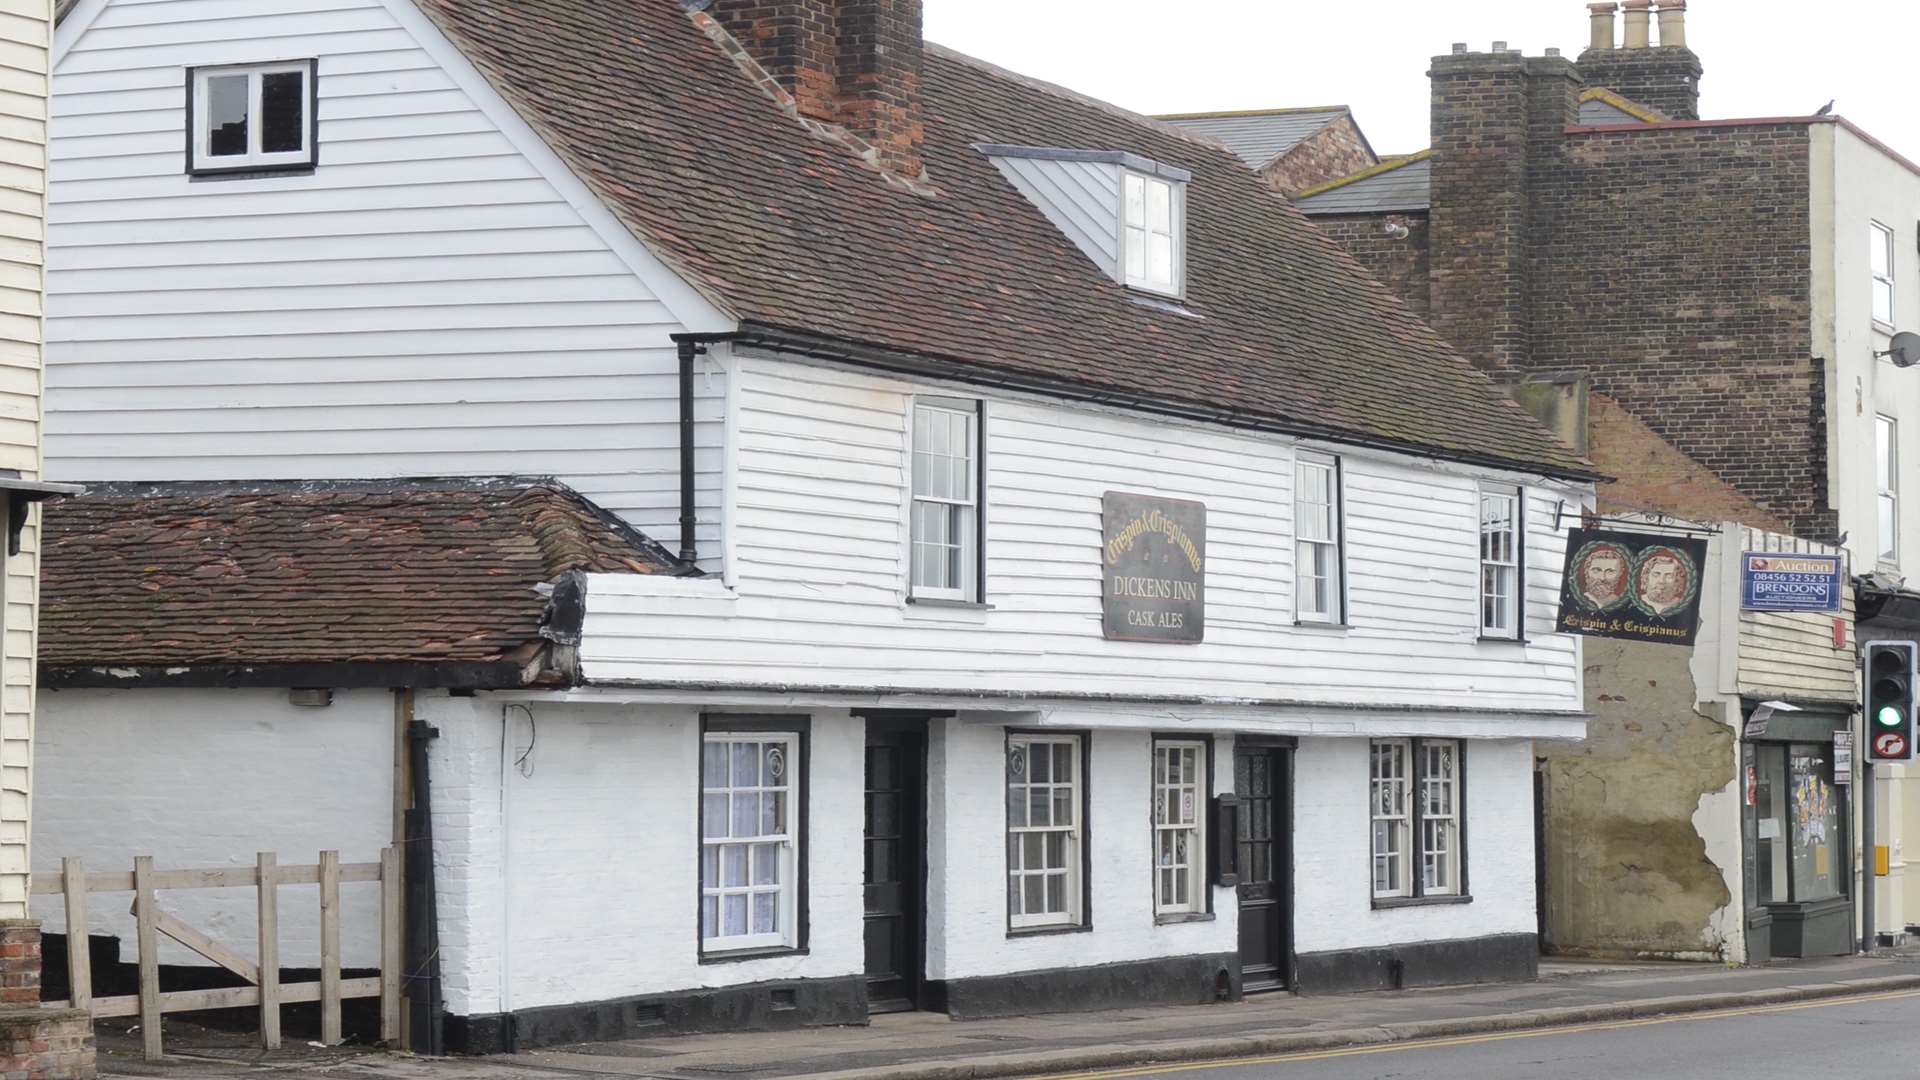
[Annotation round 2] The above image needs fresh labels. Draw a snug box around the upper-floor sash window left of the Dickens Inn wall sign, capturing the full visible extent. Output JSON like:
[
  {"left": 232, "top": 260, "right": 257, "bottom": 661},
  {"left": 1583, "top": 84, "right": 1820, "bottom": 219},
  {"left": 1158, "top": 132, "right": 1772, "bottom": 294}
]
[{"left": 910, "top": 398, "right": 981, "bottom": 601}]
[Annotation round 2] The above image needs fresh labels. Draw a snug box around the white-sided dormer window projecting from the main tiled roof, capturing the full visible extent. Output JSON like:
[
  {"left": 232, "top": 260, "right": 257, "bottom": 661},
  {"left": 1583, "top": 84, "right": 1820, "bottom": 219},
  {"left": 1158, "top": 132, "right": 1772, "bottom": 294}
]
[{"left": 973, "top": 142, "right": 1192, "bottom": 304}]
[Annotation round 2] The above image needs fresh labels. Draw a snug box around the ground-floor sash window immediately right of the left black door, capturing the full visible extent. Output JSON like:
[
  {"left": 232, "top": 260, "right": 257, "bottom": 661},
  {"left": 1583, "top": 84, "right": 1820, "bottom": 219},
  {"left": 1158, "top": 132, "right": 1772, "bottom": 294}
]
[{"left": 1006, "top": 732, "right": 1085, "bottom": 930}]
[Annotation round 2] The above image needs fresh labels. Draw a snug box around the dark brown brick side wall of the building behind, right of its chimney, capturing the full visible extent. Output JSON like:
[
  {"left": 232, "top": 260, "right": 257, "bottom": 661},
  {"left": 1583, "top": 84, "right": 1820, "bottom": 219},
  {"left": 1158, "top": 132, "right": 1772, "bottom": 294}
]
[{"left": 1526, "top": 125, "right": 1836, "bottom": 540}]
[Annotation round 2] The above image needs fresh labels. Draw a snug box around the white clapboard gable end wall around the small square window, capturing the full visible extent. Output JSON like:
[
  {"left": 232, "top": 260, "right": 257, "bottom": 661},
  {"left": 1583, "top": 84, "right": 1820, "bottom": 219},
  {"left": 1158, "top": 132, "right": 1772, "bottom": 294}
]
[{"left": 48, "top": 0, "right": 726, "bottom": 548}]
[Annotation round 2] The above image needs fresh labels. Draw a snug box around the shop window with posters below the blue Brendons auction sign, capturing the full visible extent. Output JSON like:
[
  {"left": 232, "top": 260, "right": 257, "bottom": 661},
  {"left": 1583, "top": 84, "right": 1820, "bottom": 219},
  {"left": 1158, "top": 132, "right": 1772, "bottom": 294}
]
[{"left": 1751, "top": 742, "right": 1847, "bottom": 903}]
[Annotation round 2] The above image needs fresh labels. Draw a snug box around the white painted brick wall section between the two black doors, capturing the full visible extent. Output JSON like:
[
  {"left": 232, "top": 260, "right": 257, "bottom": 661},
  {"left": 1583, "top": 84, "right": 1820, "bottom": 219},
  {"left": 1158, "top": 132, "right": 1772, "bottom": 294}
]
[{"left": 927, "top": 719, "right": 1228, "bottom": 978}]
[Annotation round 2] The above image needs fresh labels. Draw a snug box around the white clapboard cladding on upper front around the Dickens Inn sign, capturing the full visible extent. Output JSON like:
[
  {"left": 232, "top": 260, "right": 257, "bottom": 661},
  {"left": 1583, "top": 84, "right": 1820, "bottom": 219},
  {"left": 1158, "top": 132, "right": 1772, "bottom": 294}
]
[{"left": 582, "top": 357, "right": 1580, "bottom": 722}]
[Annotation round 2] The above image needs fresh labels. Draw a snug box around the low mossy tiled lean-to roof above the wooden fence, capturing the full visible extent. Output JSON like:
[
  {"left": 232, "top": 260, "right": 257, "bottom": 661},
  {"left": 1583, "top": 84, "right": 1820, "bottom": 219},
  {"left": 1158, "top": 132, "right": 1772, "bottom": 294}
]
[{"left": 40, "top": 479, "right": 672, "bottom": 673}]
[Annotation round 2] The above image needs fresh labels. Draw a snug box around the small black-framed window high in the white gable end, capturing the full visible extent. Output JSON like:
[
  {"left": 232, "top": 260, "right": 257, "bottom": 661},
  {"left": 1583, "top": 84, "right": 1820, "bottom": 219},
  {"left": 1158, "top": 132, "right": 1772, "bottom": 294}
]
[{"left": 188, "top": 60, "right": 315, "bottom": 173}]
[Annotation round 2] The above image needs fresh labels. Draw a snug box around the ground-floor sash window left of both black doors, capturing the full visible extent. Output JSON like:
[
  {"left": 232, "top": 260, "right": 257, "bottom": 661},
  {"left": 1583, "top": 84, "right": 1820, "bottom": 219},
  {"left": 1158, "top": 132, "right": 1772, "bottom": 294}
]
[{"left": 701, "top": 719, "right": 801, "bottom": 951}]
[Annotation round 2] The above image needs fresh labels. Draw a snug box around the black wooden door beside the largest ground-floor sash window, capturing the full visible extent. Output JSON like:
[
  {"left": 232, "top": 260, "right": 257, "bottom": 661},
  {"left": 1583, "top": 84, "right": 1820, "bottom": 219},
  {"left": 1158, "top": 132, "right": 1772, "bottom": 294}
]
[{"left": 866, "top": 721, "right": 927, "bottom": 1013}]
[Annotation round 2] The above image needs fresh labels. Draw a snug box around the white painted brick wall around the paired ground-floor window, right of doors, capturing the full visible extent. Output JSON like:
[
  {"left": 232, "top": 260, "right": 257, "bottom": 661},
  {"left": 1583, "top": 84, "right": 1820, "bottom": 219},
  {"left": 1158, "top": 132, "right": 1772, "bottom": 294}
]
[{"left": 1294, "top": 738, "right": 1536, "bottom": 953}]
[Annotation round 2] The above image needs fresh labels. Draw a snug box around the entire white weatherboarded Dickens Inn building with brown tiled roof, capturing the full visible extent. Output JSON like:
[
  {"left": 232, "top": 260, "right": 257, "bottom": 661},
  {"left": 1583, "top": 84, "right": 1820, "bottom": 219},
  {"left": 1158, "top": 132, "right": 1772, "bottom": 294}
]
[{"left": 42, "top": 0, "right": 1594, "bottom": 1051}]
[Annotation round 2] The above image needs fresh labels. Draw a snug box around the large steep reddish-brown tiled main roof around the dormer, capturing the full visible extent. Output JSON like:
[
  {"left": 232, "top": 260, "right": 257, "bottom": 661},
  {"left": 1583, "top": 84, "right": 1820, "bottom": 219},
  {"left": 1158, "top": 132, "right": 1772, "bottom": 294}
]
[{"left": 419, "top": 0, "right": 1592, "bottom": 475}]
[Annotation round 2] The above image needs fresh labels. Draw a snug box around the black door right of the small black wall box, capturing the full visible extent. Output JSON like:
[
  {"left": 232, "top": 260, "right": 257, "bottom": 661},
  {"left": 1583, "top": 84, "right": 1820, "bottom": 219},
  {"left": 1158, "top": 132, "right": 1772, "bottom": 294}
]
[{"left": 1233, "top": 746, "right": 1294, "bottom": 992}]
